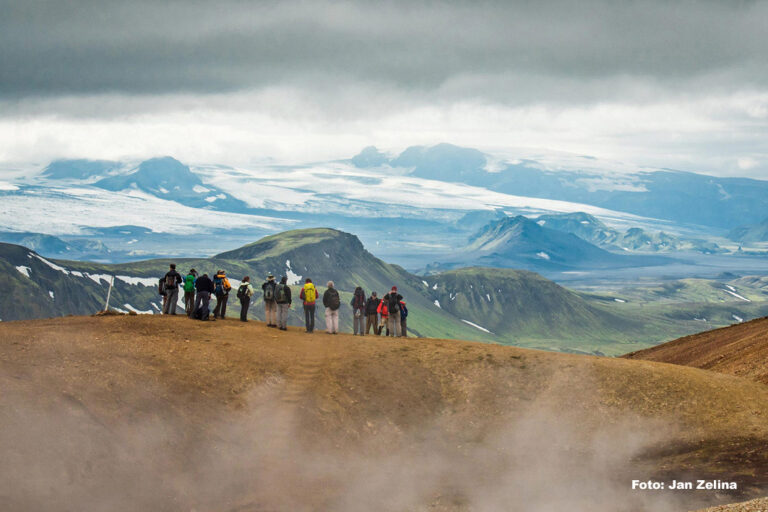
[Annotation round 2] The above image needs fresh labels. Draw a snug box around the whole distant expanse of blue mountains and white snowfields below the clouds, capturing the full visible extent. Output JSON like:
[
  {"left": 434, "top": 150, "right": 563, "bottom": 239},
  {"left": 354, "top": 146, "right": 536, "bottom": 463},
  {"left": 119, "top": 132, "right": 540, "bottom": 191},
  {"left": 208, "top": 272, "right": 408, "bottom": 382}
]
[{"left": 0, "top": 144, "right": 768, "bottom": 269}]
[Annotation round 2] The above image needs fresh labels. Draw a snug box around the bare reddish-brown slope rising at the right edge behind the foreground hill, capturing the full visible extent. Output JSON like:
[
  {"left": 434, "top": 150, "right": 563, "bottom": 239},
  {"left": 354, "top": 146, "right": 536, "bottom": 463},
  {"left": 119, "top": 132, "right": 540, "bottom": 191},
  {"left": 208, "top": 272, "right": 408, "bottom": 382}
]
[{"left": 623, "top": 318, "right": 768, "bottom": 384}]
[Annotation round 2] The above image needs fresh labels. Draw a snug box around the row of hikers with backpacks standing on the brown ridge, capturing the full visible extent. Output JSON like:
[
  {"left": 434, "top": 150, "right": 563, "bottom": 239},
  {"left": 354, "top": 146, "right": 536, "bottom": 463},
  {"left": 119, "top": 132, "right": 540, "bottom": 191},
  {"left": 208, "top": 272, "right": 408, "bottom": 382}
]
[{"left": 158, "top": 263, "right": 408, "bottom": 337}]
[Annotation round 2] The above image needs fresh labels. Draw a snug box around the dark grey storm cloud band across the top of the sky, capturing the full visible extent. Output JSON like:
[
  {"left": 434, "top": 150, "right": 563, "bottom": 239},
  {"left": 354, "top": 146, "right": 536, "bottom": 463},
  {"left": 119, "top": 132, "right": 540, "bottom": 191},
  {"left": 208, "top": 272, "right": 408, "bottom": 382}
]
[{"left": 0, "top": 0, "right": 768, "bottom": 102}]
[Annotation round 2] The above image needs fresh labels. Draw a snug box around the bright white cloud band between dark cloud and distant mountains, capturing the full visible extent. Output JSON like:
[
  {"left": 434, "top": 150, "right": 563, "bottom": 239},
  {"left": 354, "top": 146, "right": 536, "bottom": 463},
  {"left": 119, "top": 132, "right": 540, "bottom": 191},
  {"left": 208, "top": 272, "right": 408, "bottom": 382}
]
[{"left": 0, "top": 89, "right": 768, "bottom": 178}]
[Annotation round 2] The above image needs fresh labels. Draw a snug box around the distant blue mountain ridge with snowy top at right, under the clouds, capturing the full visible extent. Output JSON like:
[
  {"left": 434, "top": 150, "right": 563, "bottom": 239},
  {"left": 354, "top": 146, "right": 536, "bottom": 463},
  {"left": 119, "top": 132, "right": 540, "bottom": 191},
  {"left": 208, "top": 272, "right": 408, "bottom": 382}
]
[{"left": 352, "top": 140, "right": 768, "bottom": 228}]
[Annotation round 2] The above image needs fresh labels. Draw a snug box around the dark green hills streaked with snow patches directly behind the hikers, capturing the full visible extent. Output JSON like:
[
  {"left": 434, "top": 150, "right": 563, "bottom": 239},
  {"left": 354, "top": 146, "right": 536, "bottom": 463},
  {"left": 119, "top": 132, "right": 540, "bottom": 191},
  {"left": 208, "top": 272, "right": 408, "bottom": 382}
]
[{"left": 0, "top": 228, "right": 766, "bottom": 354}]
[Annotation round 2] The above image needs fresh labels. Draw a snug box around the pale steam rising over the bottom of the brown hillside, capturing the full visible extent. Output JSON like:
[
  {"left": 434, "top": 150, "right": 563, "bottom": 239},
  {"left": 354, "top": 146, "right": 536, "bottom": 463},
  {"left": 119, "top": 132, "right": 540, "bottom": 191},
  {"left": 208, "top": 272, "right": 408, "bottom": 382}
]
[{"left": 0, "top": 372, "right": 696, "bottom": 512}]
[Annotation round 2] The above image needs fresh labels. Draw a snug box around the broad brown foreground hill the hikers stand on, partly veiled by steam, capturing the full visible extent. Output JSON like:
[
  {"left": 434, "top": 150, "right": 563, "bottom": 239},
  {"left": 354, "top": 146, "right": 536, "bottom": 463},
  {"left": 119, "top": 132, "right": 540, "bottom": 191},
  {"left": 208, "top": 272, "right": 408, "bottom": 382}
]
[{"left": 0, "top": 316, "right": 768, "bottom": 512}]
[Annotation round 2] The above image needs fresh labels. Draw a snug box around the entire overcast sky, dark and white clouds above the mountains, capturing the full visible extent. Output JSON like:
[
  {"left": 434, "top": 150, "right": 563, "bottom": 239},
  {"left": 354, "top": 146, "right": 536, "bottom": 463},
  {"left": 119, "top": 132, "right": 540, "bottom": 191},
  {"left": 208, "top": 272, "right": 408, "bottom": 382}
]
[{"left": 0, "top": 0, "right": 768, "bottom": 179}]
